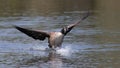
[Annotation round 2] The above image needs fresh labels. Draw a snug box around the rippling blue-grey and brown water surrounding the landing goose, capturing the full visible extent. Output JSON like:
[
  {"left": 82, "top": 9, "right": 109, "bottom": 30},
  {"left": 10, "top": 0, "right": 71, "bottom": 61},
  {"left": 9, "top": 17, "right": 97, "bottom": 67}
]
[{"left": 0, "top": 0, "right": 120, "bottom": 68}]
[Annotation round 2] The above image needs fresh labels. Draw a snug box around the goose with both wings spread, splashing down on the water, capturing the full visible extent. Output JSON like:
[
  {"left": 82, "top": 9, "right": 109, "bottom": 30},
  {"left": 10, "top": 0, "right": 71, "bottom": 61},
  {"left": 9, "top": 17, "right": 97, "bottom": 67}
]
[{"left": 14, "top": 14, "right": 89, "bottom": 49}]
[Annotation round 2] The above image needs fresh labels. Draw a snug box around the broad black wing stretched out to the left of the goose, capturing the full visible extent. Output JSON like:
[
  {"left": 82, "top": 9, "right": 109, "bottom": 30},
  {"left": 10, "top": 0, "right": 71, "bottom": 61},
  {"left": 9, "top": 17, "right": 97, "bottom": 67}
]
[{"left": 14, "top": 26, "right": 49, "bottom": 41}]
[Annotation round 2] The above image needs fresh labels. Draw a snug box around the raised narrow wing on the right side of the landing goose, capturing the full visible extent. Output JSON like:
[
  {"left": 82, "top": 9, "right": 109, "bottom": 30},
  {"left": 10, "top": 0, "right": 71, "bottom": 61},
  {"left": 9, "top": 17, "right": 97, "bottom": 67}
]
[{"left": 61, "top": 13, "right": 89, "bottom": 35}]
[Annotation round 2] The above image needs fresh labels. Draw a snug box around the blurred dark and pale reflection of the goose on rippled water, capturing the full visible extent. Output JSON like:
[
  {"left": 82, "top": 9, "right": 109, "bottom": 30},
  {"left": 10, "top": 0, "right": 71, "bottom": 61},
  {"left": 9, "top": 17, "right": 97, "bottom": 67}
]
[{"left": 17, "top": 51, "right": 63, "bottom": 68}]
